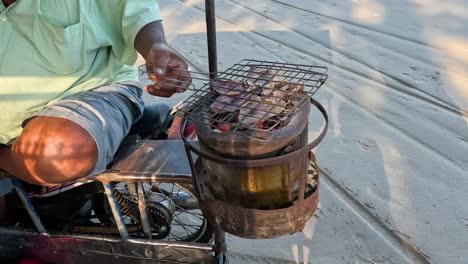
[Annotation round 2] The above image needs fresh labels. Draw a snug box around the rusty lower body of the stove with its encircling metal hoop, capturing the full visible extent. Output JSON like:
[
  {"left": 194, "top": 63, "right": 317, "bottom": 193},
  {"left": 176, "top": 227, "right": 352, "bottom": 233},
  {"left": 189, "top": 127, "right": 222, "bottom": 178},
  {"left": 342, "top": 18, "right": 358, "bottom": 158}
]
[{"left": 183, "top": 98, "right": 328, "bottom": 239}]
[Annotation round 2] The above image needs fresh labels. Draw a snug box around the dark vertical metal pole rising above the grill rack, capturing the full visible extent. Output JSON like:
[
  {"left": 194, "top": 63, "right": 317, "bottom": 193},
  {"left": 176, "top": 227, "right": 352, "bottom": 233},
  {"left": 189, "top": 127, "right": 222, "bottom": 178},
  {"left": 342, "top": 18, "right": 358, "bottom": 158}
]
[{"left": 205, "top": 0, "right": 218, "bottom": 79}]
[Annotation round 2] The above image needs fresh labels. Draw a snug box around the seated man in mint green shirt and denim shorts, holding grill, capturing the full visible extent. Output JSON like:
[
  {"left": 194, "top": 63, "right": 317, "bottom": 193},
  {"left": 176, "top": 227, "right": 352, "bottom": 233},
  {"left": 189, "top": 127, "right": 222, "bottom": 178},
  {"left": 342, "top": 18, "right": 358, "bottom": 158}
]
[{"left": 0, "top": 0, "right": 191, "bottom": 185}]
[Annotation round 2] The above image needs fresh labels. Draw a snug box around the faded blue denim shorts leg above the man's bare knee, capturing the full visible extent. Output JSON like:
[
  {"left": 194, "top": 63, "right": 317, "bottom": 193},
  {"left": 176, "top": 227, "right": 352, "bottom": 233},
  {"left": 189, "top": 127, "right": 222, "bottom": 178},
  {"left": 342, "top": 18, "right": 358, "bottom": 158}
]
[{"left": 34, "top": 82, "right": 144, "bottom": 175}]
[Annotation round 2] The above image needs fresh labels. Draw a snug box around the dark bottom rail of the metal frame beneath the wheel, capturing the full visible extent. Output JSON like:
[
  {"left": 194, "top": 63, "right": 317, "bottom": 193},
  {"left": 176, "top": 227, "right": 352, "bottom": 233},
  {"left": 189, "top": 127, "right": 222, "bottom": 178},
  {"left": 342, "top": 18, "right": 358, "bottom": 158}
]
[{"left": 0, "top": 228, "right": 216, "bottom": 264}]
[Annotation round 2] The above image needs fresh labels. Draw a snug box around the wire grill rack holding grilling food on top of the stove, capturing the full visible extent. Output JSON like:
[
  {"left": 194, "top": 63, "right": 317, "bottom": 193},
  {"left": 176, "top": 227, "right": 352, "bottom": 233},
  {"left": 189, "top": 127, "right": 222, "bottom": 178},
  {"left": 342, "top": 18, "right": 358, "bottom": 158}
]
[{"left": 141, "top": 59, "right": 328, "bottom": 140}]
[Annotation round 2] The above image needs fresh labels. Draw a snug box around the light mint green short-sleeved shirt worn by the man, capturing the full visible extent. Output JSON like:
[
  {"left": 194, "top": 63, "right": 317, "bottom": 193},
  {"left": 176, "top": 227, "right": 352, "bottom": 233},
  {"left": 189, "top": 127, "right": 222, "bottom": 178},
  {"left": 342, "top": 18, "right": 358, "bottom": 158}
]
[{"left": 0, "top": 0, "right": 161, "bottom": 144}]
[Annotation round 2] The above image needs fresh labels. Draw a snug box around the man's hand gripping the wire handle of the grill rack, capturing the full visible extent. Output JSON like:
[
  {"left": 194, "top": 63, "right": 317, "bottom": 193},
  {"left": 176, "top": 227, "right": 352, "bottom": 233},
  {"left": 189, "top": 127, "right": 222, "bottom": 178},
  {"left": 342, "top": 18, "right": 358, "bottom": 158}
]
[{"left": 145, "top": 43, "right": 192, "bottom": 97}]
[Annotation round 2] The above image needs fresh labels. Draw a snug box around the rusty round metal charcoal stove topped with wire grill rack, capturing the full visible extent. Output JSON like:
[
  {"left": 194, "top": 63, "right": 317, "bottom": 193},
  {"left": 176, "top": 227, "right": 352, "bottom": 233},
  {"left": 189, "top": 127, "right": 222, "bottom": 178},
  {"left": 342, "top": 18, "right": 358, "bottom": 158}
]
[{"left": 178, "top": 60, "right": 328, "bottom": 238}]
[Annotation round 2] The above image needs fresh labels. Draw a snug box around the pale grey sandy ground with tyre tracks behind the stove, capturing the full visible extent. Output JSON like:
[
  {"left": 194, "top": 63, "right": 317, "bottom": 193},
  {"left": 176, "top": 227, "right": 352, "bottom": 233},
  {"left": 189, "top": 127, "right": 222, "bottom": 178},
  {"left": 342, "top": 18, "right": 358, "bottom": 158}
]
[{"left": 141, "top": 0, "right": 468, "bottom": 263}]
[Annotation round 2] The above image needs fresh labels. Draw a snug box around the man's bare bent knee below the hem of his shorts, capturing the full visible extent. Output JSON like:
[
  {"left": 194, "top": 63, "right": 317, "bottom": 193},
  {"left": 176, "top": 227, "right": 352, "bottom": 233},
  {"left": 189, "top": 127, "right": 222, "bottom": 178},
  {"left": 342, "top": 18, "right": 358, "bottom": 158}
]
[{"left": 11, "top": 117, "right": 98, "bottom": 184}]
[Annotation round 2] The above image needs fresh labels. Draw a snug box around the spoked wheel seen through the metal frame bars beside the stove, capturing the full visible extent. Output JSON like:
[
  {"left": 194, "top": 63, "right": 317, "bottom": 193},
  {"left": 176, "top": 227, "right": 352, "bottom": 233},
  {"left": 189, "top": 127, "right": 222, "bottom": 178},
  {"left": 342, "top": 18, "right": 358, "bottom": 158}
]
[{"left": 93, "top": 182, "right": 214, "bottom": 243}]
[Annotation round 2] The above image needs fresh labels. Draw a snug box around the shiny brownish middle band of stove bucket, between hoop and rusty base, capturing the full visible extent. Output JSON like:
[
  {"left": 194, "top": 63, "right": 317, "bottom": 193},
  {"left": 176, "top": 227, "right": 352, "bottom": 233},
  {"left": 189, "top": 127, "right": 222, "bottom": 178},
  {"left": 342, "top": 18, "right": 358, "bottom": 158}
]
[{"left": 197, "top": 138, "right": 308, "bottom": 209}]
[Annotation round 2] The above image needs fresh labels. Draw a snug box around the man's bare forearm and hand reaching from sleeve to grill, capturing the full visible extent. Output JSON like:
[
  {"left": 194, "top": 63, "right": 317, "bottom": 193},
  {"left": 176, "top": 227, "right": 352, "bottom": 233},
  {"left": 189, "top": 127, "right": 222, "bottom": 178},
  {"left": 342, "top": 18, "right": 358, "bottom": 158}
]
[{"left": 135, "top": 21, "right": 192, "bottom": 97}]
